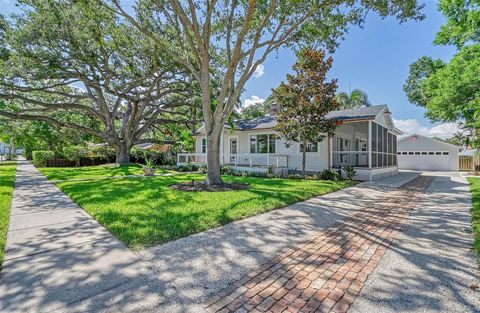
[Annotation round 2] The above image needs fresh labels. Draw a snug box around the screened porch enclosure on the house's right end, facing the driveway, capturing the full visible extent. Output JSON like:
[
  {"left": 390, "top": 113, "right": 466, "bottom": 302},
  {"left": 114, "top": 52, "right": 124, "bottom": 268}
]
[{"left": 332, "top": 121, "right": 397, "bottom": 168}]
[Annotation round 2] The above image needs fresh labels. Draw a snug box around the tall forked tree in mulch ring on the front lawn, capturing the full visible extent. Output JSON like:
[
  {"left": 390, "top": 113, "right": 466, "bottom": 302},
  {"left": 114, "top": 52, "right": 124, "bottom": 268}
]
[{"left": 107, "top": 0, "right": 423, "bottom": 184}]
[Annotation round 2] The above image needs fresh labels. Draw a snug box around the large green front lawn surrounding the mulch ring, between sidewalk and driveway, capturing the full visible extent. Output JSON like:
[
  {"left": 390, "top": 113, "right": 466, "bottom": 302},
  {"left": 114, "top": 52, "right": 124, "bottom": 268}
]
[{"left": 58, "top": 174, "right": 353, "bottom": 249}]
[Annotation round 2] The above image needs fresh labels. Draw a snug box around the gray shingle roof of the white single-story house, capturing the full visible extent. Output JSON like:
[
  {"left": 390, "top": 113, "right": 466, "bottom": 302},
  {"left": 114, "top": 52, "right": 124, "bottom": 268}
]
[{"left": 235, "top": 105, "right": 387, "bottom": 130}]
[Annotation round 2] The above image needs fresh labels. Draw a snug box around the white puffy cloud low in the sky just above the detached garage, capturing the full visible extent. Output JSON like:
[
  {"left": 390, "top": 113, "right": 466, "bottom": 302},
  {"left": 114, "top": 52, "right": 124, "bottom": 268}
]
[{"left": 393, "top": 119, "right": 463, "bottom": 138}]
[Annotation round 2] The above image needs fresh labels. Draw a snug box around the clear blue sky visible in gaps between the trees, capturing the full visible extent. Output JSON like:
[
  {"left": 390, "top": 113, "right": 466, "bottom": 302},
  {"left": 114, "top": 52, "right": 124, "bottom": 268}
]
[{"left": 0, "top": 0, "right": 457, "bottom": 137}]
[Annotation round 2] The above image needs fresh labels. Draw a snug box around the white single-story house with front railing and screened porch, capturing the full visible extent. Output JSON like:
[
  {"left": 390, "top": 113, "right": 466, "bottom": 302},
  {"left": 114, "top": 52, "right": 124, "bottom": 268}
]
[{"left": 177, "top": 105, "right": 402, "bottom": 180}]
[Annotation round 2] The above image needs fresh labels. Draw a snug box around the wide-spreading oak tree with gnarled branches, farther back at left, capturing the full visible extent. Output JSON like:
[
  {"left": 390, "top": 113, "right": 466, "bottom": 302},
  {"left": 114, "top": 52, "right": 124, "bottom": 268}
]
[{"left": 0, "top": 0, "right": 194, "bottom": 163}]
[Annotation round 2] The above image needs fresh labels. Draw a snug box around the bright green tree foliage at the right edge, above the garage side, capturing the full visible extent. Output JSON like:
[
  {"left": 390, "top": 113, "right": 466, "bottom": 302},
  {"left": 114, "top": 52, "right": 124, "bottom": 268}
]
[{"left": 404, "top": 0, "right": 480, "bottom": 144}]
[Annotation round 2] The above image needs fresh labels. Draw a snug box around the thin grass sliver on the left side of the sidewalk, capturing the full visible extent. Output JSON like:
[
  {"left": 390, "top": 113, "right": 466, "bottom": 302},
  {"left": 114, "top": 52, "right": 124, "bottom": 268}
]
[{"left": 0, "top": 162, "right": 17, "bottom": 268}]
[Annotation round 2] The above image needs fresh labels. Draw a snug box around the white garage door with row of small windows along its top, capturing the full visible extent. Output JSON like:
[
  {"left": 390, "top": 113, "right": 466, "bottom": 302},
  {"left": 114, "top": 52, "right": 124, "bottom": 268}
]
[{"left": 398, "top": 151, "right": 450, "bottom": 171}]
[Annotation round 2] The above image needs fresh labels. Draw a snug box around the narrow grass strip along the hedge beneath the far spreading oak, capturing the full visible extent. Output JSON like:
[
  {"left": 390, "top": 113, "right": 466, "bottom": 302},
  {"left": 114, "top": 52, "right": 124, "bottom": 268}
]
[{"left": 38, "top": 164, "right": 169, "bottom": 180}]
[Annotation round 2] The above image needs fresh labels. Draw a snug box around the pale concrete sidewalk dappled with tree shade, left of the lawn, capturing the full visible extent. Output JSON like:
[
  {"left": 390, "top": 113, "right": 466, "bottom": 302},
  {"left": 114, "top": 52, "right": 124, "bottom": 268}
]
[{"left": 0, "top": 161, "right": 143, "bottom": 312}]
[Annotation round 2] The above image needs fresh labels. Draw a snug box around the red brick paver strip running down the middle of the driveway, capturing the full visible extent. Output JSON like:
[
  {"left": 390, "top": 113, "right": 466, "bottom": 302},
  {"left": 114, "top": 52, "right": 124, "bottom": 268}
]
[{"left": 205, "top": 176, "right": 433, "bottom": 312}]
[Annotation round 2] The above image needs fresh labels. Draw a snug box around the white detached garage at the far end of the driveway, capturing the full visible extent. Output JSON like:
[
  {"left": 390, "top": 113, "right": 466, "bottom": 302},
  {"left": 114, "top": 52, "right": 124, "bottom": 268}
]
[{"left": 397, "top": 134, "right": 459, "bottom": 171}]
